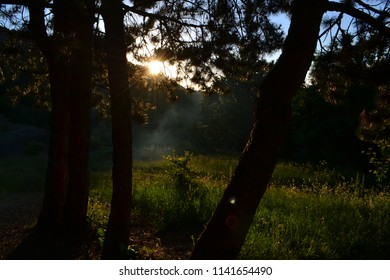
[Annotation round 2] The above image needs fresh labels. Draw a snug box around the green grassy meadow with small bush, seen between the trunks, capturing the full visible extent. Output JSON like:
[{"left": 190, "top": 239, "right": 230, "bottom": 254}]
[{"left": 0, "top": 154, "right": 390, "bottom": 259}]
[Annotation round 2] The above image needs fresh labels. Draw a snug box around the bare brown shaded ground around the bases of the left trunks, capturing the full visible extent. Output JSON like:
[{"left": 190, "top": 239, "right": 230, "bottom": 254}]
[{"left": 0, "top": 193, "right": 192, "bottom": 259}]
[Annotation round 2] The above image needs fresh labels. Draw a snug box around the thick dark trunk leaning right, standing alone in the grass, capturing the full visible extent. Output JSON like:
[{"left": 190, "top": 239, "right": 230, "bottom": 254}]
[{"left": 191, "top": 0, "right": 327, "bottom": 259}]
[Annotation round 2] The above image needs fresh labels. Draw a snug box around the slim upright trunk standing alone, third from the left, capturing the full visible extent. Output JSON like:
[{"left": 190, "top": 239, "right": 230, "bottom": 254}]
[{"left": 102, "top": 0, "right": 132, "bottom": 259}]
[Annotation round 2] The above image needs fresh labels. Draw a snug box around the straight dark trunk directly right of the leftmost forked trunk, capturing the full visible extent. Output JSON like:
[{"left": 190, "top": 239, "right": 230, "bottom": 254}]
[{"left": 65, "top": 0, "right": 93, "bottom": 233}]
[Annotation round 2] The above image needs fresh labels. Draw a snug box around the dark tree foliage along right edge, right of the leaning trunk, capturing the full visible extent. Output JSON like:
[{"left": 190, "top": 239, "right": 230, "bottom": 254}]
[{"left": 311, "top": 25, "right": 390, "bottom": 182}]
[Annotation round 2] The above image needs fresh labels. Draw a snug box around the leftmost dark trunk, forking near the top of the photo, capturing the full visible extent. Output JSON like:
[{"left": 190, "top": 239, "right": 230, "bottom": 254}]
[{"left": 29, "top": 0, "right": 70, "bottom": 229}]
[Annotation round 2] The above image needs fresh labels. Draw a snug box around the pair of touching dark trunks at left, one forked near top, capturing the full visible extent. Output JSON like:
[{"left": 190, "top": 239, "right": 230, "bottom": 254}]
[{"left": 29, "top": 0, "right": 93, "bottom": 233}]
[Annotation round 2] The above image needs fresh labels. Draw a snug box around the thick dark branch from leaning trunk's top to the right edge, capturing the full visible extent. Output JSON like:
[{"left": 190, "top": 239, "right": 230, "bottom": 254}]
[{"left": 327, "top": 1, "right": 390, "bottom": 37}]
